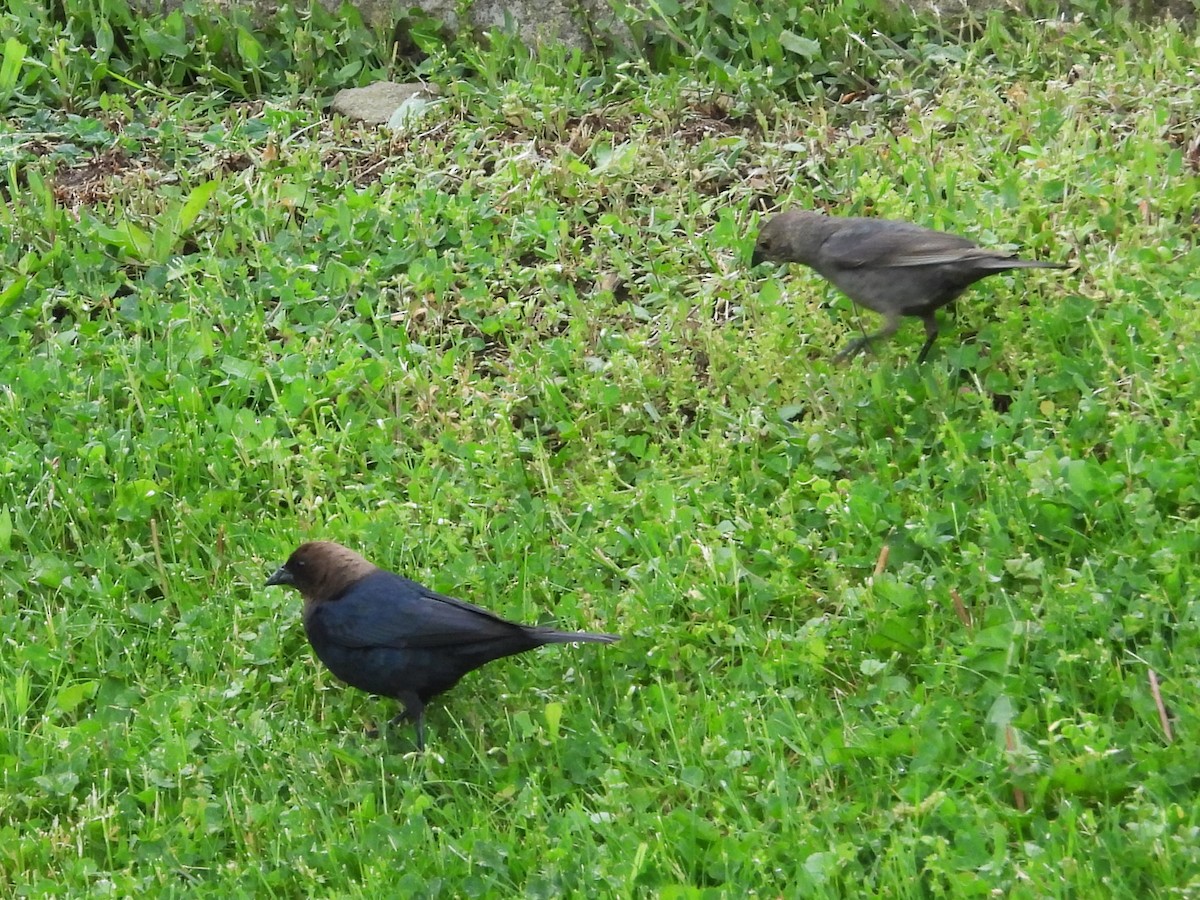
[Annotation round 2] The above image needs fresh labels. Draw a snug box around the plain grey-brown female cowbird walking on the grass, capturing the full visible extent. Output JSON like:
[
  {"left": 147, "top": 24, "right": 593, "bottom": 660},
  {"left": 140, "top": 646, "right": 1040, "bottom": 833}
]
[{"left": 750, "top": 210, "right": 1067, "bottom": 362}]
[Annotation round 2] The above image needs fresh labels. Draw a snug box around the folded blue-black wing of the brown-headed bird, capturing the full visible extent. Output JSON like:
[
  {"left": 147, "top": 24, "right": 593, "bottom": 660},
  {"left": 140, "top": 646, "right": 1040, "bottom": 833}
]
[{"left": 311, "top": 571, "right": 521, "bottom": 649}]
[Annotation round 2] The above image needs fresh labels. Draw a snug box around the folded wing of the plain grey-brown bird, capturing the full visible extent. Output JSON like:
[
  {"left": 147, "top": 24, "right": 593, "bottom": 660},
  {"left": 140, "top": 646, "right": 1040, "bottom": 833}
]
[{"left": 821, "top": 220, "right": 1002, "bottom": 269}]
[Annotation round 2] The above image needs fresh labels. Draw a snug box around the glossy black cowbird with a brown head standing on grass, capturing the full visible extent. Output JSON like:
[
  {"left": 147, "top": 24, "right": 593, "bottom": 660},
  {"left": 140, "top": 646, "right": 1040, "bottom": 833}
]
[{"left": 266, "top": 541, "right": 617, "bottom": 749}]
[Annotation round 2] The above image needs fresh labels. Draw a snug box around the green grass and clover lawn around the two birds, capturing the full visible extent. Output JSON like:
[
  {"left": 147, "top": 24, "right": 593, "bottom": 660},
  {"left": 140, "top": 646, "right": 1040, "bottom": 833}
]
[{"left": 0, "top": 1, "right": 1200, "bottom": 898}]
